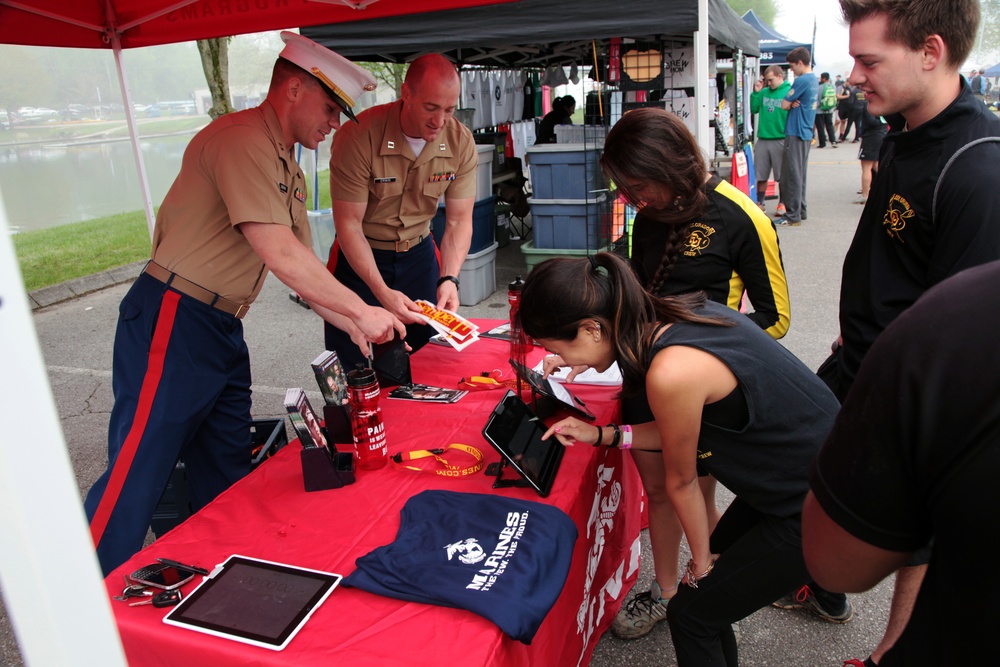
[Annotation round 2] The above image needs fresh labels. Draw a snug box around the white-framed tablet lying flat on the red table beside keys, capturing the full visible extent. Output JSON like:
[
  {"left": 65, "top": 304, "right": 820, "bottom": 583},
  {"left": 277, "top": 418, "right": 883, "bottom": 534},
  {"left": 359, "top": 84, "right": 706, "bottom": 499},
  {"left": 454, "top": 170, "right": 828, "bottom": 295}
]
[{"left": 163, "top": 555, "right": 343, "bottom": 651}]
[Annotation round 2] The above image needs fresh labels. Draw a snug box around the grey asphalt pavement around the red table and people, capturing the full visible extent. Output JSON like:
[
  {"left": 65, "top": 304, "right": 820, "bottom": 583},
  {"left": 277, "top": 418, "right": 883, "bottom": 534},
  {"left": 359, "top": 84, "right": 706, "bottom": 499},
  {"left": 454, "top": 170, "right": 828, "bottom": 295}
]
[{"left": 0, "top": 144, "right": 892, "bottom": 667}]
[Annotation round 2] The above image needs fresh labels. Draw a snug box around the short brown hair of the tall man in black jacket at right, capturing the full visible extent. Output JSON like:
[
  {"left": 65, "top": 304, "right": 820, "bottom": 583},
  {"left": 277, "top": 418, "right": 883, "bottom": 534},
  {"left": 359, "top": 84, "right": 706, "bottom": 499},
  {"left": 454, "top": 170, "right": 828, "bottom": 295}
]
[{"left": 840, "top": 0, "right": 980, "bottom": 68}]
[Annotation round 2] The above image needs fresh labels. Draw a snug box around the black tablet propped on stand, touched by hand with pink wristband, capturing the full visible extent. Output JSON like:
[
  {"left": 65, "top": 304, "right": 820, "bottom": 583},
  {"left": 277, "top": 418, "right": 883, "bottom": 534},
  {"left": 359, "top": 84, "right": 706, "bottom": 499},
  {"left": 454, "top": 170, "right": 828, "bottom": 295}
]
[{"left": 483, "top": 390, "right": 564, "bottom": 496}]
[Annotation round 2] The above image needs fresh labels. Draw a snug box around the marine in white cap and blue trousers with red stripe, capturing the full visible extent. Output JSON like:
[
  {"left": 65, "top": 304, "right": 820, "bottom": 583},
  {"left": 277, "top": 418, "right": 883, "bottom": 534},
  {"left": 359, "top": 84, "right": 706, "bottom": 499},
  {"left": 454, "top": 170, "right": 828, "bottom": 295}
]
[{"left": 84, "top": 32, "right": 417, "bottom": 575}]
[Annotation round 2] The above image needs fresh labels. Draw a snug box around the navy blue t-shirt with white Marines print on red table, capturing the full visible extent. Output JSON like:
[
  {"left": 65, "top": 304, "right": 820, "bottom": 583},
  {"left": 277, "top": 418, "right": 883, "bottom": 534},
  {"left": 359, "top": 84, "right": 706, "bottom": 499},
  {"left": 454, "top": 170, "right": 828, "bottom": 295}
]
[{"left": 343, "top": 491, "right": 577, "bottom": 644}]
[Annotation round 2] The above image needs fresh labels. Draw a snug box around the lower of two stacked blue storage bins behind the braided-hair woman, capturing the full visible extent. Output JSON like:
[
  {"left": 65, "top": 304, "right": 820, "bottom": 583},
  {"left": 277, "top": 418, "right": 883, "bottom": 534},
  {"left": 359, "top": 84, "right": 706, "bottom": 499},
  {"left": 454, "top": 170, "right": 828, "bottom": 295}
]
[{"left": 528, "top": 195, "right": 608, "bottom": 250}]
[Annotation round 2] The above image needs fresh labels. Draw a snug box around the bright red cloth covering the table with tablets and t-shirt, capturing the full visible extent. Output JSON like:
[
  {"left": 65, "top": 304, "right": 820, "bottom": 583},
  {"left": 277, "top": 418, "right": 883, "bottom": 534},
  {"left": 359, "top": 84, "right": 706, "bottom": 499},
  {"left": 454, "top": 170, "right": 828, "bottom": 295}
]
[{"left": 106, "top": 321, "right": 641, "bottom": 667}]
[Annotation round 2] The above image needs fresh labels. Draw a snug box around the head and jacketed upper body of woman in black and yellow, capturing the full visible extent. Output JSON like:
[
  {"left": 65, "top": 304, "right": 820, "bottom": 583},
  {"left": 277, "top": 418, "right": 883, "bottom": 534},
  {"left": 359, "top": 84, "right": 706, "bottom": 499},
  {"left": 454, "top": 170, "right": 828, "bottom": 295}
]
[{"left": 601, "top": 108, "right": 791, "bottom": 338}]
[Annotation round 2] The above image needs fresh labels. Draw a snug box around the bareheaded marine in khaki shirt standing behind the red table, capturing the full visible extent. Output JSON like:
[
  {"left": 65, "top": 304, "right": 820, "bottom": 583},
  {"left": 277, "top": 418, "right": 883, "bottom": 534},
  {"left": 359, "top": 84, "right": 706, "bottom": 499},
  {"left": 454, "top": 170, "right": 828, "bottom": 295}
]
[{"left": 326, "top": 55, "right": 478, "bottom": 367}]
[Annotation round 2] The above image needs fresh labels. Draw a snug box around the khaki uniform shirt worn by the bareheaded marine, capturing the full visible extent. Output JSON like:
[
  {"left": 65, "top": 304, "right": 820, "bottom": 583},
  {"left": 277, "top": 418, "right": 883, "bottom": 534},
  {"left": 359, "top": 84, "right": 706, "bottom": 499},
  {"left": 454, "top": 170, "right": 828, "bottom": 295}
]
[{"left": 330, "top": 100, "right": 479, "bottom": 241}]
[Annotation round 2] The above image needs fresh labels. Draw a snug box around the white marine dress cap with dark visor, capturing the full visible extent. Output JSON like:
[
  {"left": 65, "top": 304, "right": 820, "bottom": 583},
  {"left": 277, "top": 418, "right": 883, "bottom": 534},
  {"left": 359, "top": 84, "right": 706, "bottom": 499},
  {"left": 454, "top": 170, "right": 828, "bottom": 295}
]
[{"left": 278, "top": 30, "right": 376, "bottom": 123}]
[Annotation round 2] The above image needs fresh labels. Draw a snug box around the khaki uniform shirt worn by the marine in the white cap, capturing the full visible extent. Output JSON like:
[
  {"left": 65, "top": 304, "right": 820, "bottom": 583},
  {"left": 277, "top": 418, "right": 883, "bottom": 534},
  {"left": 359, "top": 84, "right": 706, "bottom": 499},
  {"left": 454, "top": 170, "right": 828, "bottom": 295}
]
[{"left": 153, "top": 101, "right": 312, "bottom": 303}]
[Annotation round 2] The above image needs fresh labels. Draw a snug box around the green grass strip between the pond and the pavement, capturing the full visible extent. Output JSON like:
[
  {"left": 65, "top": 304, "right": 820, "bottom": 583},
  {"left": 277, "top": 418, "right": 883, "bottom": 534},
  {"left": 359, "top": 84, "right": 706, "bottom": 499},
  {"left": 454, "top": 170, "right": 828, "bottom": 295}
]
[{"left": 13, "top": 170, "right": 330, "bottom": 292}]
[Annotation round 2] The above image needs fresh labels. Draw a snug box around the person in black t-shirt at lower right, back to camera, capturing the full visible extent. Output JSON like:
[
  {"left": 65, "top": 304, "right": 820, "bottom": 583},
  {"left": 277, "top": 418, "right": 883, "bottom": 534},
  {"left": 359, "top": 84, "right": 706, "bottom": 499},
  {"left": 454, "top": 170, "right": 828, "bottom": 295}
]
[{"left": 802, "top": 262, "right": 1000, "bottom": 667}]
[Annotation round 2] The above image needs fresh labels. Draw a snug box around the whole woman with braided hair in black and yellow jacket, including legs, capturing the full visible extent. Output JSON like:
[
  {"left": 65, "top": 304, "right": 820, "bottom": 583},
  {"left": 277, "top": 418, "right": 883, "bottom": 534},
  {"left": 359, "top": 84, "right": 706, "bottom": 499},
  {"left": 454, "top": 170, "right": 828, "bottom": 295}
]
[{"left": 584, "top": 108, "right": 790, "bottom": 639}]
